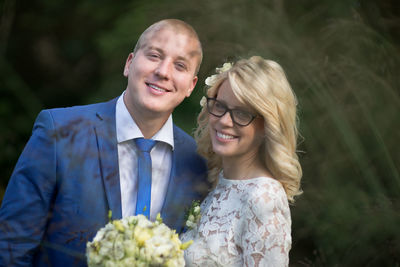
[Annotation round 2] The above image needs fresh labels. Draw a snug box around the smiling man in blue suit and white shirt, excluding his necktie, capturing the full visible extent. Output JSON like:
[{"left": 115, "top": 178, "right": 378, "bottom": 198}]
[{"left": 0, "top": 19, "right": 207, "bottom": 266}]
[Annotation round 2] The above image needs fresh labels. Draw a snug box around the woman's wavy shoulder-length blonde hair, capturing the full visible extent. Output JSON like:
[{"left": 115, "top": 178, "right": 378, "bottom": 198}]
[{"left": 194, "top": 56, "right": 302, "bottom": 202}]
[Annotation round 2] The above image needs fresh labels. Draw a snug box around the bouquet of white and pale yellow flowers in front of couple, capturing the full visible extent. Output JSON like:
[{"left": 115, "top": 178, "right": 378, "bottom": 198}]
[{"left": 86, "top": 215, "right": 191, "bottom": 267}]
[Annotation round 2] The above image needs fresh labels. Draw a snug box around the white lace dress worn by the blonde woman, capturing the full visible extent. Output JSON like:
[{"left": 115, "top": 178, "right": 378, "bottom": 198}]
[{"left": 181, "top": 175, "right": 292, "bottom": 267}]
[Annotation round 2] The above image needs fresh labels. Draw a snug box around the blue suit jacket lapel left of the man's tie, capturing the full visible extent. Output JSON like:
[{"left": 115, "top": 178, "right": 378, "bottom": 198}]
[{"left": 94, "top": 98, "right": 122, "bottom": 219}]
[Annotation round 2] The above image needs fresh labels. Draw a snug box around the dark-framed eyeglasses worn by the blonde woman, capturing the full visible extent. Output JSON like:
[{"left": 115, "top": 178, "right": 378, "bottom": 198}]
[{"left": 207, "top": 97, "right": 257, "bottom": 126}]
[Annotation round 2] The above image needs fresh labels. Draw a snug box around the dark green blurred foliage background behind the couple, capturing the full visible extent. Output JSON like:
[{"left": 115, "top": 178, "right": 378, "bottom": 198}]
[{"left": 0, "top": 0, "right": 400, "bottom": 266}]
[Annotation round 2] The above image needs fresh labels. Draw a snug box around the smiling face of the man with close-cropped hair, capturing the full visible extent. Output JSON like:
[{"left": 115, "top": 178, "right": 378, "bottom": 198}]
[{"left": 124, "top": 27, "right": 199, "bottom": 118}]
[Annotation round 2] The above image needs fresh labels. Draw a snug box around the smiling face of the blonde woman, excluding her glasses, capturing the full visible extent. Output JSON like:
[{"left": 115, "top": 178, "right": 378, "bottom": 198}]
[{"left": 209, "top": 80, "right": 264, "bottom": 161}]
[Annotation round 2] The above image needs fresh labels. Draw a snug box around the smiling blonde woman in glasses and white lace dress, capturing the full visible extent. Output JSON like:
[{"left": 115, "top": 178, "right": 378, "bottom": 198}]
[{"left": 182, "top": 56, "right": 302, "bottom": 267}]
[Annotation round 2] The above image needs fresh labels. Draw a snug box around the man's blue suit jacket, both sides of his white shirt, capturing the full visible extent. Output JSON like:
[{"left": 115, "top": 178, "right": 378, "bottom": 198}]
[{"left": 0, "top": 99, "right": 207, "bottom": 266}]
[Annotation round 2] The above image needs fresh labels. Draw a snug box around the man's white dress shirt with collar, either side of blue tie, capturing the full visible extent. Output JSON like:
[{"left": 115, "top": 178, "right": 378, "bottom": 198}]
[{"left": 115, "top": 93, "right": 174, "bottom": 220}]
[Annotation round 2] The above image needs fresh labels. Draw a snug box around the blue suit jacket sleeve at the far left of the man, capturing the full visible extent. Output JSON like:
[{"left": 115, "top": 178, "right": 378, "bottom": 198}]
[{"left": 0, "top": 111, "right": 56, "bottom": 266}]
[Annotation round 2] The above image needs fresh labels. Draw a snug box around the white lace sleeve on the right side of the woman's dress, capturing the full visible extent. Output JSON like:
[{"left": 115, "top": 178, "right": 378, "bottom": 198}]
[{"left": 241, "top": 178, "right": 291, "bottom": 266}]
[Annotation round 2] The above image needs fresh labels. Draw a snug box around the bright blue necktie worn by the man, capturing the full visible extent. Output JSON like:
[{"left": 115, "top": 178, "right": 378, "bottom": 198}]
[{"left": 135, "top": 138, "right": 156, "bottom": 219}]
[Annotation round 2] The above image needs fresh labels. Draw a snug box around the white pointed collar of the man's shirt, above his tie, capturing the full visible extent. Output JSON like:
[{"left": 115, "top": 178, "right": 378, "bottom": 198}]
[{"left": 115, "top": 92, "right": 174, "bottom": 150}]
